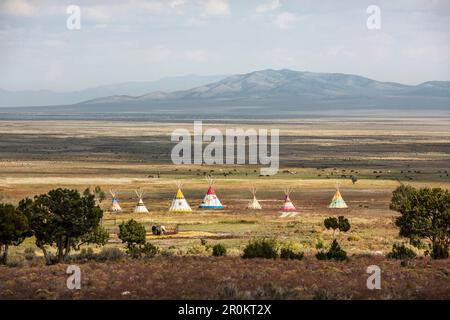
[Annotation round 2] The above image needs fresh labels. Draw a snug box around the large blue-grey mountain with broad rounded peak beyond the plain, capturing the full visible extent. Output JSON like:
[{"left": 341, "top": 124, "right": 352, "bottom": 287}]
[{"left": 0, "top": 69, "right": 450, "bottom": 115}]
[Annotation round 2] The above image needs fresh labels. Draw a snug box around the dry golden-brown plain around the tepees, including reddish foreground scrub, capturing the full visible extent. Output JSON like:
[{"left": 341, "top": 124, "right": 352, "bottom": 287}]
[{"left": 0, "top": 118, "right": 450, "bottom": 299}]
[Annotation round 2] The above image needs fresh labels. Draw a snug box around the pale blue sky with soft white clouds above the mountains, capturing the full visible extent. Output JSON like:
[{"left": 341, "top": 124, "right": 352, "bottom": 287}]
[{"left": 0, "top": 0, "right": 450, "bottom": 91}]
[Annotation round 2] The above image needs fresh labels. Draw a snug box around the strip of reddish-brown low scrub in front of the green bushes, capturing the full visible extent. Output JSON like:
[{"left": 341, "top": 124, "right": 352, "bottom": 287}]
[{"left": 0, "top": 256, "right": 450, "bottom": 299}]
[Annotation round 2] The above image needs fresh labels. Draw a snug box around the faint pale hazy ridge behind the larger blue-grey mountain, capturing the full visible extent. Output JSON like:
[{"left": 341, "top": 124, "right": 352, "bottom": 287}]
[{"left": 0, "top": 75, "right": 226, "bottom": 107}]
